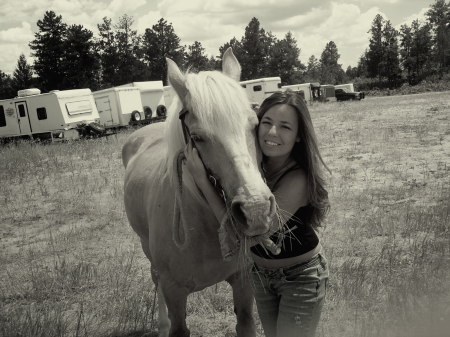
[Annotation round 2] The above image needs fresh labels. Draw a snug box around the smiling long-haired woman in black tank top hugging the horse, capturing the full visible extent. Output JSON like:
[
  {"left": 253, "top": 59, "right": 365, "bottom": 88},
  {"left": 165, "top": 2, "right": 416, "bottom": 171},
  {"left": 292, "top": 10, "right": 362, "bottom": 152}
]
[{"left": 186, "top": 91, "right": 329, "bottom": 337}]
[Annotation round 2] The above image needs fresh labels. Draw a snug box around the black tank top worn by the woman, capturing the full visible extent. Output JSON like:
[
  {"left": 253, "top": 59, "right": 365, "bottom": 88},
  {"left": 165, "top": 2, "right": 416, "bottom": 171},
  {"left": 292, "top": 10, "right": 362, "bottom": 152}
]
[{"left": 250, "top": 167, "right": 319, "bottom": 259}]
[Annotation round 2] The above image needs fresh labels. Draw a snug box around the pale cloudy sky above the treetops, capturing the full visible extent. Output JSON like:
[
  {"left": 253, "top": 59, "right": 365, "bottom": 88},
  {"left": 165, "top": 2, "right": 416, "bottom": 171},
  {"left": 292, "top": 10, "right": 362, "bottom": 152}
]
[{"left": 0, "top": 0, "right": 428, "bottom": 74}]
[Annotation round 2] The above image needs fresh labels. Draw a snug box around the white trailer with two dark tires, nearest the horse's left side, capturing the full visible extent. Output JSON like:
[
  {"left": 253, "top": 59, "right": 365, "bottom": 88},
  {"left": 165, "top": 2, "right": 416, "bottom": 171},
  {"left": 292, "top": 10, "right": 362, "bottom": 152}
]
[{"left": 119, "top": 81, "right": 167, "bottom": 119}]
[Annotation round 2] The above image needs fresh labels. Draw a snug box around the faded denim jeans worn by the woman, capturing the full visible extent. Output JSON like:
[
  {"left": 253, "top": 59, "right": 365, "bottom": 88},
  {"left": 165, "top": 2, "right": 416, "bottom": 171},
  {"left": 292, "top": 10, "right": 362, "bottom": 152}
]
[{"left": 252, "top": 253, "right": 328, "bottom": 337}]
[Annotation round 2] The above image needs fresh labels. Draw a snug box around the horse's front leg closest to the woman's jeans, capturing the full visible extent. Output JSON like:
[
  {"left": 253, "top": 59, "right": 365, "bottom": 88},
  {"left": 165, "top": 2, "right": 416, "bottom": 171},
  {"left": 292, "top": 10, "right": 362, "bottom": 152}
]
[{"left": 227, "top": 271, "right": 256, "bottom": 337}]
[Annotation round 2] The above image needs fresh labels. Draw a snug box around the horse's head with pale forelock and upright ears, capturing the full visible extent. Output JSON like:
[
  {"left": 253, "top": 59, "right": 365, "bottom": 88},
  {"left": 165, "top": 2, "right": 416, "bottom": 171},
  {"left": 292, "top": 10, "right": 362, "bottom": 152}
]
[{"left": 167, "top": 48, "right": 275, "bottom": 236}]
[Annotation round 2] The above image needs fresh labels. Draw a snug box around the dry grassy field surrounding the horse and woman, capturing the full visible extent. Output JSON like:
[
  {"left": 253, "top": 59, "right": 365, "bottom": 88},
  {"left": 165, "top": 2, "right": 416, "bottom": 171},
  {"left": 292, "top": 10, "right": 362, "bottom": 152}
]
[{"left": 0, "top": 92, "right": 450, "bottom": 337}]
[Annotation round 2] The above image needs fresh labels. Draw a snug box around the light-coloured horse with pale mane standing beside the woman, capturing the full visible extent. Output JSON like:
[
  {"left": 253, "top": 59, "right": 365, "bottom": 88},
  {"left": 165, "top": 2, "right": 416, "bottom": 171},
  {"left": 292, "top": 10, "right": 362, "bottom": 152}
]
[{"left": 122, "top": 48, "right": 276, "bottom": 337}]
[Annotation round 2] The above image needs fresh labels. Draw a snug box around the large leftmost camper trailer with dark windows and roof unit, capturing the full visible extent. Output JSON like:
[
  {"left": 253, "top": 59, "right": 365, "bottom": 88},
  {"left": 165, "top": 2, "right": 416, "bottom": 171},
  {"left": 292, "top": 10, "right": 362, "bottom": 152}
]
[{"left": 0, "top": 88, "right": 102, "bottom": 139}]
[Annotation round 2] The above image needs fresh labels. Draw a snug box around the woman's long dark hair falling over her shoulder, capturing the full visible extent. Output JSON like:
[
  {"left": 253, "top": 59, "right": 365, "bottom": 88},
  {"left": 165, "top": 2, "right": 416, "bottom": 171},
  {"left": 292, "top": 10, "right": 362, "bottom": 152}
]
[{"left": 258, "top": 90, "right": 331, "bottom": 228}]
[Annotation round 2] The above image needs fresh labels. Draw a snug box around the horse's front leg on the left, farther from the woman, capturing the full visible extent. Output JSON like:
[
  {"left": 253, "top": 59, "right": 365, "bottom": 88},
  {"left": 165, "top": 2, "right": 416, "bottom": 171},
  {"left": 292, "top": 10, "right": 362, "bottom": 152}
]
[{"left": 160, "top": 278, "right": 190, "bottom": 337}]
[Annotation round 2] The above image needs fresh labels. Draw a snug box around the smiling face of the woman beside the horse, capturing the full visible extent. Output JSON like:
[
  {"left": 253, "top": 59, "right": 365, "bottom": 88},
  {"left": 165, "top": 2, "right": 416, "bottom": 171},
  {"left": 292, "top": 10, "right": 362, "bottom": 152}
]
[{"left": 258, "top": 104, "right": 300, "bottom": 157}]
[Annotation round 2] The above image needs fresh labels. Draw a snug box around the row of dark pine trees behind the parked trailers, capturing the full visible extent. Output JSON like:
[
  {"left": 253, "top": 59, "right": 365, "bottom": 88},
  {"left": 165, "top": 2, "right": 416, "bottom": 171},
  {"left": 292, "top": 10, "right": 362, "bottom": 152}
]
[{"left": 0, "top": 0, "right": 450, "bottom": 98}]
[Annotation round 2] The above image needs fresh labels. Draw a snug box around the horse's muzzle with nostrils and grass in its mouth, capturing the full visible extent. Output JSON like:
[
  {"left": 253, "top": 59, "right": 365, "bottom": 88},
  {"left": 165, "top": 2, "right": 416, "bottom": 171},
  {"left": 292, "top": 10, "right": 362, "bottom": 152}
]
[{"left": 231, "top": 191, "right": 276, "bottom": 237}]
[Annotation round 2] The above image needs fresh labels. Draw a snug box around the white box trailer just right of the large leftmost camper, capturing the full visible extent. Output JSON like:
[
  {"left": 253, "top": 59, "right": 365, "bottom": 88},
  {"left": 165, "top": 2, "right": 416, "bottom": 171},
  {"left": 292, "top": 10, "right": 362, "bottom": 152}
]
[{"left": 92, "top": 87, "right": 144, "bottom": 128}]
